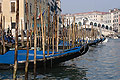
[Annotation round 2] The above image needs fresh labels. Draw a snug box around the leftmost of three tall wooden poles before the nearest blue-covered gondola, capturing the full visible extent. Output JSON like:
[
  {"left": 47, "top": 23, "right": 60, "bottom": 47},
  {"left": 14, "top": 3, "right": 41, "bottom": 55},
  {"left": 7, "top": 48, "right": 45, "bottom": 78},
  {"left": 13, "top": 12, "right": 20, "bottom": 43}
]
[{"left": 13, "top": 0, "right": 19, "bottom": 80}]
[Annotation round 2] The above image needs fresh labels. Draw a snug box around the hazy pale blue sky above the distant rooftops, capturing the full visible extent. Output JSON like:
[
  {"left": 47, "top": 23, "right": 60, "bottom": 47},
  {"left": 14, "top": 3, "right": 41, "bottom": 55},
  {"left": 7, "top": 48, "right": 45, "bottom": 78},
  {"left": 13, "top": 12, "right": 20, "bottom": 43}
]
[{"left": 61, "top": 0, "right": 120, "bottom": 14}]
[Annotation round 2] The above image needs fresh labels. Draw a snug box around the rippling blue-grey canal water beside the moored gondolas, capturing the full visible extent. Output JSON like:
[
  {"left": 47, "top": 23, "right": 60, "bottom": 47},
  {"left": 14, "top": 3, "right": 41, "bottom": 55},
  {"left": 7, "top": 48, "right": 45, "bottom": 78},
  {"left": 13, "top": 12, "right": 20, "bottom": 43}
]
[{"left": 0, "top": 39, "right": 120, "bottom": 80}]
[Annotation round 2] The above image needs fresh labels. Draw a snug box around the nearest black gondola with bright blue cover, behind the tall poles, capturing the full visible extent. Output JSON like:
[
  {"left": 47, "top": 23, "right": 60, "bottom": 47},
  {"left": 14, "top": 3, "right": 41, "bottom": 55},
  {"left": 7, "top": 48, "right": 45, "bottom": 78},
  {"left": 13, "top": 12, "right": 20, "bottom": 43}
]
[{"left": 0, "top": 44, "right": 89, "bottom": 69}]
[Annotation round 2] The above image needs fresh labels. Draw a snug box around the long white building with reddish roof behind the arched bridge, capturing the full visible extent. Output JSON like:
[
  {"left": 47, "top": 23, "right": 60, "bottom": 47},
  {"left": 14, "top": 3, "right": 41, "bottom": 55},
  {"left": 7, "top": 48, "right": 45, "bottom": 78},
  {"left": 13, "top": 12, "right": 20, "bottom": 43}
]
[{"left": 62, "top": 11, "right": 111, "bottom": 28}]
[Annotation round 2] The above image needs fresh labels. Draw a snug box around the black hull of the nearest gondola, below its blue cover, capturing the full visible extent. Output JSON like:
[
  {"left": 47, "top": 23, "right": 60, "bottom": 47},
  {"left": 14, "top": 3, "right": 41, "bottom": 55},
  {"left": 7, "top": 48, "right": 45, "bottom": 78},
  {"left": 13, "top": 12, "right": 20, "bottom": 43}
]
[{"left": 0, "top": 44, "right": 89, "bottom": 69}]
